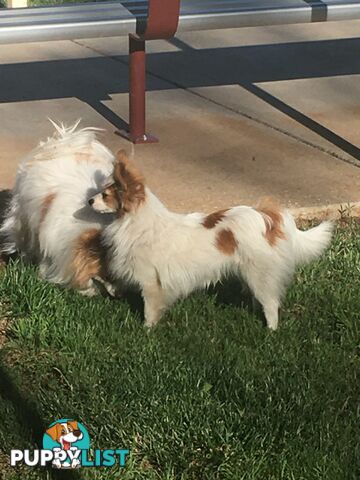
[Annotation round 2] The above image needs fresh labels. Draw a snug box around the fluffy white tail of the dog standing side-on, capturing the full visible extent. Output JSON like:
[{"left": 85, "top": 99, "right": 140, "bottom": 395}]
[{"left": 294, "top": 221, "right": 334, "bottom": 265}]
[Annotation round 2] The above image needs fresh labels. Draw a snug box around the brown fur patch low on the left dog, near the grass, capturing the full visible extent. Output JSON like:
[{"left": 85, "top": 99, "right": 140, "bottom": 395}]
[{"left": 71, "top": 228, "right": 106, "bottom": 288}]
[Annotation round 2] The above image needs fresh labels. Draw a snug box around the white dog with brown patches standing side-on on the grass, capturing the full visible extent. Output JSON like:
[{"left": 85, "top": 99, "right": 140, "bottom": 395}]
[{"left": 89, "top": 151, "right": 332, "bottom": 330}]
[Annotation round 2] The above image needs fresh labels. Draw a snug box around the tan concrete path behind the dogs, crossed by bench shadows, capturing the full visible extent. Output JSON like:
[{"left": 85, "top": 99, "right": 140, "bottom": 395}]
[{"left": 0, "top": 21, "right": 360, "bottom": 211}]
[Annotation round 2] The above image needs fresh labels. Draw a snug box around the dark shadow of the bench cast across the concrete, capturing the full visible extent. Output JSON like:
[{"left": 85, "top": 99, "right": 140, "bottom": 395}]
[{"left": 0, "top": 38, "right": 360, "bottom": 159}]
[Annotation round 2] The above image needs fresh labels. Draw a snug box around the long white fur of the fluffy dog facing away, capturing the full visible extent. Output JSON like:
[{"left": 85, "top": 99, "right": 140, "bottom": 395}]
[{"left": 0, "top": 122, "right": 114, "bottom": 285}]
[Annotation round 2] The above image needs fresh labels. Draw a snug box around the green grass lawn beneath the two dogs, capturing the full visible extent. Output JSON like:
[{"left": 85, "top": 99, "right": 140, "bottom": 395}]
[{"left": 0, "top": 221, "right": 360, "bottom": 480}]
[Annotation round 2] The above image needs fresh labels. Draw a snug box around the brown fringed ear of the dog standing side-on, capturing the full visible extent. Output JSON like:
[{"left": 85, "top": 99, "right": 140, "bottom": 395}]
[{"left": 114, "top": 150, "right": 145, "bottom": 213}]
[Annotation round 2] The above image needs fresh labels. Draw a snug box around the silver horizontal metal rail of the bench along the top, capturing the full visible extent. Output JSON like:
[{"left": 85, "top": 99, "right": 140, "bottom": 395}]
[{"left": 0, "top": 0, "right": 360, "bottom": 44}]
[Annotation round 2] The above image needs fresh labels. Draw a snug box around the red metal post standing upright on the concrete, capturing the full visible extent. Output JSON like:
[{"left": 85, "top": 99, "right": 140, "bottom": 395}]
[{"left": 129, "top": 35, "right": 158, "bottom": 143}]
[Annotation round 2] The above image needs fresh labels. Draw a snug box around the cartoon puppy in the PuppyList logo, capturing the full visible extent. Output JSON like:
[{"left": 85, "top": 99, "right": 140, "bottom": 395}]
[{"left": 45, "top": 420, "right": 84, "bottom": 468}]
